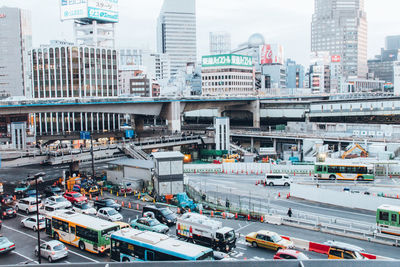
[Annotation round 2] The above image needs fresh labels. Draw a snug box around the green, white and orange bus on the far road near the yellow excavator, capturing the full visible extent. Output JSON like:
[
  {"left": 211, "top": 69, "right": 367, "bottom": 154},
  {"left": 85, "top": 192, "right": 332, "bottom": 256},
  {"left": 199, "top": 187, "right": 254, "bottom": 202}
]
[{"left": 314, "top": 164, "right": 375, "bottom": 181}]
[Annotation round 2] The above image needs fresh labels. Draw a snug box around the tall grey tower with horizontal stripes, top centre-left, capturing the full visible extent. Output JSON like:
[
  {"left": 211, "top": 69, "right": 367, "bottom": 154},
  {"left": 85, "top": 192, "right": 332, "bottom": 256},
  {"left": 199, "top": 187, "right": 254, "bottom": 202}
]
[{"left": 157, "top": 0, "right": 197, "bottom": 76}]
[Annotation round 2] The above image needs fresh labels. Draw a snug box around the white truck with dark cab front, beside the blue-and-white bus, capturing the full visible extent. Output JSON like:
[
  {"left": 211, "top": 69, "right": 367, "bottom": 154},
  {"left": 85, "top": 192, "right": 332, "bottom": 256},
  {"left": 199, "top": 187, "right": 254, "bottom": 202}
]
[{"left": 176, "top": 212, "right": 236, "bottom": 252}]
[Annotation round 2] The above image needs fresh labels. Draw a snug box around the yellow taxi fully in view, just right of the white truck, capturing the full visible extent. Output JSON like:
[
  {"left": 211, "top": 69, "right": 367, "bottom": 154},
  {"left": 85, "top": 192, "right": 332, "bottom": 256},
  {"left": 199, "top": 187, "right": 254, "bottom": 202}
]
[{"left": 246, "top": 230, "right": 293, "bottom": 251}]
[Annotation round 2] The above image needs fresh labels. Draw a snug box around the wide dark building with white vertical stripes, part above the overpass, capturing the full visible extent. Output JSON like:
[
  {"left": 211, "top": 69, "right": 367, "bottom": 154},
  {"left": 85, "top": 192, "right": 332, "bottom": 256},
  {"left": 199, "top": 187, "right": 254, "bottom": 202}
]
[{"left": 30, "top": 46, "right": 119, "bottom": 98}]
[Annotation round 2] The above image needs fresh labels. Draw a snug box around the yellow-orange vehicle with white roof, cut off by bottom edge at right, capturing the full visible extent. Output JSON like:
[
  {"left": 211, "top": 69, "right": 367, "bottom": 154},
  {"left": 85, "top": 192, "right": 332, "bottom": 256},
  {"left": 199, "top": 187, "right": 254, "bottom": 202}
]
[{"left": 325, "top": 241, "right": 366, "bottom": 260}]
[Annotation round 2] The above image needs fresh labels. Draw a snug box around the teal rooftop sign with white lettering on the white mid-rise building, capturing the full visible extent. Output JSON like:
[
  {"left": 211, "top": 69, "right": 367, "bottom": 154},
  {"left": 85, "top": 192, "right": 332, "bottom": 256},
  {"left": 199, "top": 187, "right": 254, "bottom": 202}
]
[{"left": 202, "top": 54, "right": 253, "bottom": 67}]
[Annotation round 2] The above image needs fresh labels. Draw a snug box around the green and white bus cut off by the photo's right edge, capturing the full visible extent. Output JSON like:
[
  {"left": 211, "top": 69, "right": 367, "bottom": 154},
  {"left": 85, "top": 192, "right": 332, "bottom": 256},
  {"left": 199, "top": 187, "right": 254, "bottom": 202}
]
[{"left": 376, "top": 205, "right": 400, "bottom": 236}]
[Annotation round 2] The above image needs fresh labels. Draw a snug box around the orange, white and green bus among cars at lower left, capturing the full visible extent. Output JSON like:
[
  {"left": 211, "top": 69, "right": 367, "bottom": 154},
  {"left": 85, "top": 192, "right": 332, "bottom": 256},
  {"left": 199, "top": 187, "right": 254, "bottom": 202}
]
[{"left": 46, "top": 210, "right": 120, "bottom": 254}]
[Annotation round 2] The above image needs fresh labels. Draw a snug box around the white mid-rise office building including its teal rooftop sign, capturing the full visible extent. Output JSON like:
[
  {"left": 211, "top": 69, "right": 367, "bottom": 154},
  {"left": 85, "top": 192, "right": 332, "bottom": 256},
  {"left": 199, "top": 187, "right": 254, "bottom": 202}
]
[{"left": 201, "top": 54, "right": 255, "bottom": 96}]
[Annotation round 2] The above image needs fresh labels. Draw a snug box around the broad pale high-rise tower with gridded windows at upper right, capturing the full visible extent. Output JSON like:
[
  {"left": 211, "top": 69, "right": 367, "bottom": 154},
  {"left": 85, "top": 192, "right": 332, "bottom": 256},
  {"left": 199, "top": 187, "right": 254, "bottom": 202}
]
[{"left": 311, "top": 0, "right": 368, "bottom": 77}]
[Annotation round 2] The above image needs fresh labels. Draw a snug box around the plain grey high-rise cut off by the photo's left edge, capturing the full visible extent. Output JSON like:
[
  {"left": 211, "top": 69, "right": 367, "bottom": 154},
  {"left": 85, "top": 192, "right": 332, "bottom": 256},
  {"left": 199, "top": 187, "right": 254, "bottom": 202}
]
[{"left": 0, "top": 7, "right": 32, "bottom": 97}]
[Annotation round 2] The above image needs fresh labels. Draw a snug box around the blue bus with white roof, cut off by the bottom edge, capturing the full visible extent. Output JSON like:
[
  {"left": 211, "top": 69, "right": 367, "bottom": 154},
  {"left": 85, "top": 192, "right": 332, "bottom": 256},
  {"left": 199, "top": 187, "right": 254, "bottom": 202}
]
[{"left": 111, "top": 228, "right": 214, "bottom": 262}]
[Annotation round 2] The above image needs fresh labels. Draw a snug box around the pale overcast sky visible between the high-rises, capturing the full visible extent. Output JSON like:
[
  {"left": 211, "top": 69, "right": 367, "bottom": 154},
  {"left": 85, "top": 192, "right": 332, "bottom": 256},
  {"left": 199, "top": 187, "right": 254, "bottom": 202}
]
[{"left": 0, "top": 0, "right": 400, "bottom": 65}]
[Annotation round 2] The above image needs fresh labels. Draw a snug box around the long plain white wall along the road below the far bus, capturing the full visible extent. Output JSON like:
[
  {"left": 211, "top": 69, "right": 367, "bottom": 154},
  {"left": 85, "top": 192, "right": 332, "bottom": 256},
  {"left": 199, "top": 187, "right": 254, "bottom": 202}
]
[{"left": 290, "top": 184, "right": 400, "bottom": 211}]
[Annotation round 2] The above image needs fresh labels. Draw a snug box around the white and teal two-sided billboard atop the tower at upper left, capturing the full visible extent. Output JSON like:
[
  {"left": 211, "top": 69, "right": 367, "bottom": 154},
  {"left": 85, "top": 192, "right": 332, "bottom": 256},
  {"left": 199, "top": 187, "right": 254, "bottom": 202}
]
[{"left": 60, "top": 0, "right": 119, "bottom": 23}]
